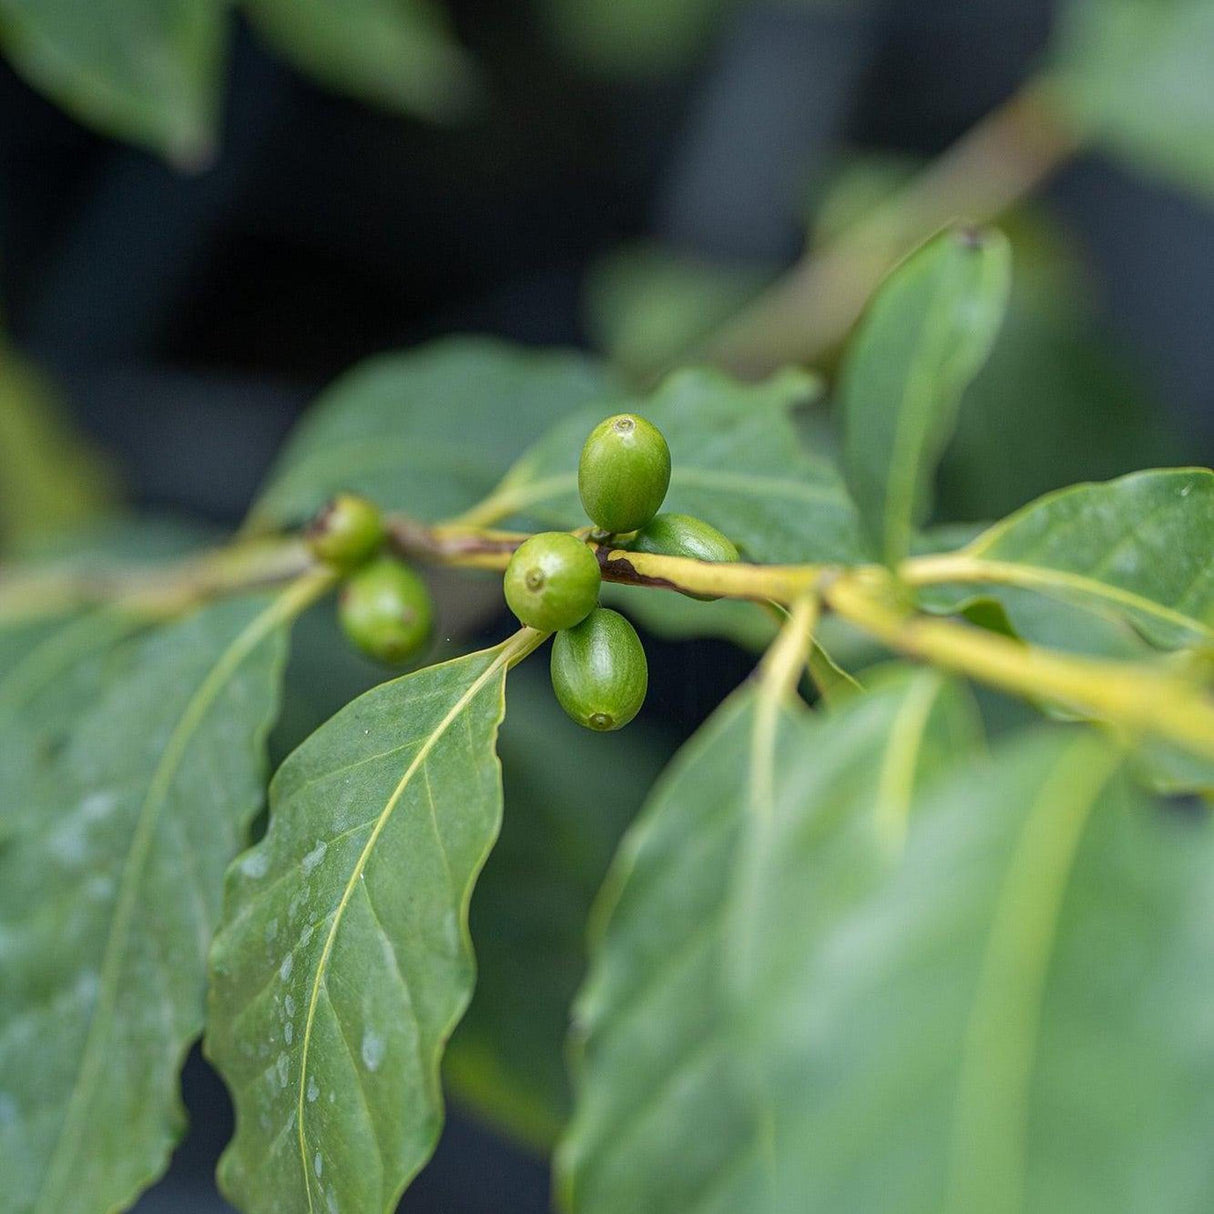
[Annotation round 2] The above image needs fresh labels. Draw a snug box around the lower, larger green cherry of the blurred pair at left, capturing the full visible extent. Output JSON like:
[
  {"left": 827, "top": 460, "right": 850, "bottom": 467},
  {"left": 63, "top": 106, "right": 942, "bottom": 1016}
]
[{"left": 337, "top": 556, "right": 433, "bottom": 665}]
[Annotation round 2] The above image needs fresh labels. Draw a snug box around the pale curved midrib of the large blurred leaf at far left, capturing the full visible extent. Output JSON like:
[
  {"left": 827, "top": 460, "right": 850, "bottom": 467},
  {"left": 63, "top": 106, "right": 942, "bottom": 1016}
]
[{"left": 34, "top": 586, "right": 300, "bottom": 1214}]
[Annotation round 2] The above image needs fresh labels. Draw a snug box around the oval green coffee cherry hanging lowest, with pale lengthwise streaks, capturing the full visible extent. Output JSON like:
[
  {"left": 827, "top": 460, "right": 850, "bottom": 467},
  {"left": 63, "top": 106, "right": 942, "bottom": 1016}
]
[{"left": 551, "top": 607, "right": 649, "bottom": 732}]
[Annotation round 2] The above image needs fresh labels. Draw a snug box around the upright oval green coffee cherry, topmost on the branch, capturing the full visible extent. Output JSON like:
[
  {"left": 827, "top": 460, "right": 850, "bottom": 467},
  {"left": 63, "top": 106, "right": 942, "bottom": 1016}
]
[{"left": 578, "top": 413, "right": 670, "bottom": 534}]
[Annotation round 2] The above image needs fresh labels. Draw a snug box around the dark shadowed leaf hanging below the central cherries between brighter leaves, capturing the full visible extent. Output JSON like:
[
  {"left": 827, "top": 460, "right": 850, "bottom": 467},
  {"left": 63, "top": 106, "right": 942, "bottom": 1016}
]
[{"left": 446, "top": 662, "right": 669, "bottom": 1152}]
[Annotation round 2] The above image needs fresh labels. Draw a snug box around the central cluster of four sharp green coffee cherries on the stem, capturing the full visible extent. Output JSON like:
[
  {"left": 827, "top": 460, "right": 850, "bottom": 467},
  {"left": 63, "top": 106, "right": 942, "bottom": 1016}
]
[{"left": 505, "top": 413, "right": 738, "bottom": 731}]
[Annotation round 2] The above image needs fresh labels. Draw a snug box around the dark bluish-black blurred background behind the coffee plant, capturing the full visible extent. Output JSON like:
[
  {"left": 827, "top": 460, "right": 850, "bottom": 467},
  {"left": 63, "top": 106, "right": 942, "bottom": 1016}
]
[{"left": 0, "top": 0, "right": 1214, "bottom": 1214}]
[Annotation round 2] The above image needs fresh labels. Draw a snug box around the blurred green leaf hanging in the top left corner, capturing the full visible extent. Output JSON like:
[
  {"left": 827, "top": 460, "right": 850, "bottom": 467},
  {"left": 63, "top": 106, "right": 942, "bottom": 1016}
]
[{"left": 0, "top": 0, "right": 228, "bottom": 168}]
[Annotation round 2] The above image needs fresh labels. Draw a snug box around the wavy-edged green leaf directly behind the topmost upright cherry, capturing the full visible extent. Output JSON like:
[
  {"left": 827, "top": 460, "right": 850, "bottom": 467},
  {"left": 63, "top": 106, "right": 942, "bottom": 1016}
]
[{"left": 486, "top": 369, "right": 867, "bottom": 562}]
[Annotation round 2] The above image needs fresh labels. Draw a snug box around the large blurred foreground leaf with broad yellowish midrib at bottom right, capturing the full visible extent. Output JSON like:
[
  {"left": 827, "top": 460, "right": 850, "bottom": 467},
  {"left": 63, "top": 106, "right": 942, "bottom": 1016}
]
[{"left": 753, "top": 728, "right": 1214, "bottom": 1214}]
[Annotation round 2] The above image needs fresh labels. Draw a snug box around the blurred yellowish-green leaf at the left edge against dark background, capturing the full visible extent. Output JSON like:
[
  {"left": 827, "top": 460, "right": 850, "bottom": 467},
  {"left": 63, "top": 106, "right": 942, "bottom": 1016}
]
[{"left": 0, "top": 340, "right": 118, "bottom": 551}]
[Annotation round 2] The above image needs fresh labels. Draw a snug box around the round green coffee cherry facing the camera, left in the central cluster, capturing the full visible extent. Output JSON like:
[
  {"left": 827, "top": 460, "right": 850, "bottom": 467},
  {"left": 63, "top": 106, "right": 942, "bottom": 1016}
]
[{"left": 505, "top": 532, "right": 602, "bottom": 632}]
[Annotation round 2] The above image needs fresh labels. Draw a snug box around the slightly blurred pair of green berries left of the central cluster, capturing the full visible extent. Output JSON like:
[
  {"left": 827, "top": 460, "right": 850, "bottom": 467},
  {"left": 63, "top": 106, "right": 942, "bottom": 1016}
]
[{"left": 307, "top": 493, "right": 435, "bottom": 665}]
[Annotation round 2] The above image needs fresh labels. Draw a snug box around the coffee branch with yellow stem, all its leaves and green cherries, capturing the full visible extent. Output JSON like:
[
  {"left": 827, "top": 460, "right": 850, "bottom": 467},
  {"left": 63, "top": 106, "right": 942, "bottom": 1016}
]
[{"left": 0, "top": 213, "right": 1214, "bottom": 1214}]
